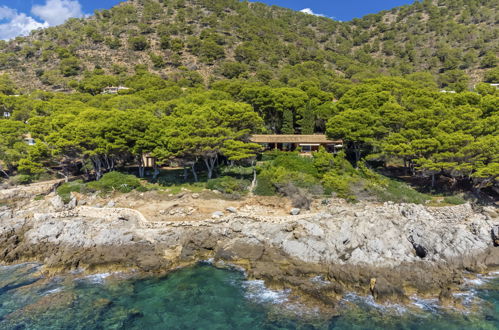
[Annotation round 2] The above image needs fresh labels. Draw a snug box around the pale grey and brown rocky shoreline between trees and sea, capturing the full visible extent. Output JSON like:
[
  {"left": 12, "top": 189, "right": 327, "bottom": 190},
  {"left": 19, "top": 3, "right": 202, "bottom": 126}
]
[{"left": 0, "top": 182, "right": 499, "bottom": 308}]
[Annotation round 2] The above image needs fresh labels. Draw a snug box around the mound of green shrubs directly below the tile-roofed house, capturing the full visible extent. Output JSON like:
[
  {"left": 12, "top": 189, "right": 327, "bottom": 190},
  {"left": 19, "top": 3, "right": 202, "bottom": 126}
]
[{"left": 255, "top": 149, "right": 438, "bottom": 204}]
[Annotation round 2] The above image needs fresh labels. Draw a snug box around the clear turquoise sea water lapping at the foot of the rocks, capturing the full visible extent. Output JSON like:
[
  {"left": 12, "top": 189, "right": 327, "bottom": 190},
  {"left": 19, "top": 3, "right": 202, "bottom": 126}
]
[{"left": 0, "top": 264, "right": 499, "bottom": 330}]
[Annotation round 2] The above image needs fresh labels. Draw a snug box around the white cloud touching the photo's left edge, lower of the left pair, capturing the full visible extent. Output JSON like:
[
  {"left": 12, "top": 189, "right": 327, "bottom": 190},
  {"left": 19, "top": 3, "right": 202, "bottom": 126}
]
[{"left": 0, "top": 6, "right": 49, "bottom": 40}]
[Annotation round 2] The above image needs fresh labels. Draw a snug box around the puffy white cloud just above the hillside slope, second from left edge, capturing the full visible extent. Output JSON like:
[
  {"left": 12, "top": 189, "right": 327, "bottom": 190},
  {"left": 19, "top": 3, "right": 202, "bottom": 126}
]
[{"left": 31, "top": 0, "right": 83, "bottom": 26}]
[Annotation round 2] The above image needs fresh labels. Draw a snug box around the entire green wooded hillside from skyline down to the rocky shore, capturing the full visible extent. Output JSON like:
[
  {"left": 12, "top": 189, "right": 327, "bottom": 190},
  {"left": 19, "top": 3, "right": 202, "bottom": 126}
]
[{"left": 0, "top": 0, "right": 499, "bottom": 200}]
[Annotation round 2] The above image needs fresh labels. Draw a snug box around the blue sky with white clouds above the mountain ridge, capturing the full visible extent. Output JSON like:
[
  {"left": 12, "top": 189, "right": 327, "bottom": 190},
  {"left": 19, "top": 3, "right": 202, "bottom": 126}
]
[{"left": 0, "top": 0, "right": 414, "bottom": 40}]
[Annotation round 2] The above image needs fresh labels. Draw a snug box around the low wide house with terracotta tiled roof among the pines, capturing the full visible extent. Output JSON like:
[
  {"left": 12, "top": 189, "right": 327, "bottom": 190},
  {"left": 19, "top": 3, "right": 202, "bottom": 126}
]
[{"left": 250, "top": 134, "right": 343, "bottom": 154}]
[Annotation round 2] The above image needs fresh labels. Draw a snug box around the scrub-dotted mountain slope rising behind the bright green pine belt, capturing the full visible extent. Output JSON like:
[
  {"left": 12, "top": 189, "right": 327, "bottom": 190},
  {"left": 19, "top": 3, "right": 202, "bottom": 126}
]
[{"left": 0, "top": 0, "right": 499, "bottom": 90}]
